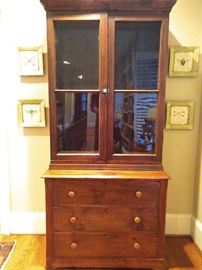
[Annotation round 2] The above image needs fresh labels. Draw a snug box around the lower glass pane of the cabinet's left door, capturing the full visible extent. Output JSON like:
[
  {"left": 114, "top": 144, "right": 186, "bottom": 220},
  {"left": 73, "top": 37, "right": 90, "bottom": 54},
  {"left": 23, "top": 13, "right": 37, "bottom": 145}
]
[{"left": 56, "top": 92, "right": 99, "bottom": 152}]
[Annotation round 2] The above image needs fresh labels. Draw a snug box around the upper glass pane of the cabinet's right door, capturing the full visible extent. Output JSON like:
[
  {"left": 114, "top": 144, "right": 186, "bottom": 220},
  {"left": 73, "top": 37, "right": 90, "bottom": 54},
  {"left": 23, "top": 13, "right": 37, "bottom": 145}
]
[{"left": 115, "top": 22, "right": 160, "bottom": 89}]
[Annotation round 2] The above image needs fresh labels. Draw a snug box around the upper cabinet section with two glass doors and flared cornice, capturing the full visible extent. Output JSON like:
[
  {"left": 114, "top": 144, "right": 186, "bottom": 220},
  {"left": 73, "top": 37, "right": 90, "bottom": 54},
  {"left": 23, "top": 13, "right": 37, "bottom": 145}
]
[{"left": 41, "top": 0, "right": 176, "bottom": 168}]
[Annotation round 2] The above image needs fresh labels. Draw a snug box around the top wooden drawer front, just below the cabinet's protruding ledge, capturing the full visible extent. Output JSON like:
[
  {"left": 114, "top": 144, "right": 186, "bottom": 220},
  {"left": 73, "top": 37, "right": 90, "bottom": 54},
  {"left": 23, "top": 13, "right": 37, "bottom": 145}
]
[{"left": 54, "top": 179, "right": 160, "bottom": 207}]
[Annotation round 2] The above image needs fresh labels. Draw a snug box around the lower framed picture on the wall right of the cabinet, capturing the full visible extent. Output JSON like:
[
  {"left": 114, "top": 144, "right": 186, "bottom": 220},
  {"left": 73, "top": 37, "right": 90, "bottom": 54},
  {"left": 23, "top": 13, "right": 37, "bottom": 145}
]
[{"left": 166, "top": 101, "right": 194, "bottom": 129}]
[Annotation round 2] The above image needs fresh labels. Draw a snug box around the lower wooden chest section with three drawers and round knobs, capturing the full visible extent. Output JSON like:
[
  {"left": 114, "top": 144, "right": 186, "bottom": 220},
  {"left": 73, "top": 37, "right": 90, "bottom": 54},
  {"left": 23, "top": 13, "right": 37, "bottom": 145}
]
[{"left": 44, "top": 171, "right": 168, "bottom": 270}]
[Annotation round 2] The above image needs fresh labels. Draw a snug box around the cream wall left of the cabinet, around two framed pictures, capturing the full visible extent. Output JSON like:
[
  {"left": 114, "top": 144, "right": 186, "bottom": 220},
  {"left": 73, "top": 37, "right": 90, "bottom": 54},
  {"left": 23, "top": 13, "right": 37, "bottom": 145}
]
[{"left": 0, "top": 0, "right": 50, "bottom": 232}]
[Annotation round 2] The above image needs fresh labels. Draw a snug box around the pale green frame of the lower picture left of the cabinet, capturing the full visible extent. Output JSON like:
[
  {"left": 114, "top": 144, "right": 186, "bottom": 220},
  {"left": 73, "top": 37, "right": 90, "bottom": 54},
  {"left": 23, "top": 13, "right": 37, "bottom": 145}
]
[{"left": 17, "top": 99, "right": 46, "bottom": 127}]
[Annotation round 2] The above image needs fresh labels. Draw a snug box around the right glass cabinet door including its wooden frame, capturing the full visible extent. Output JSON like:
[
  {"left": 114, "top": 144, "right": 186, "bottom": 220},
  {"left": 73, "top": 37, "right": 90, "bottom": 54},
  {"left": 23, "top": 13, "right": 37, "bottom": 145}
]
[{"left": 108, "top": 17, "right": 166, "bottom": 163}]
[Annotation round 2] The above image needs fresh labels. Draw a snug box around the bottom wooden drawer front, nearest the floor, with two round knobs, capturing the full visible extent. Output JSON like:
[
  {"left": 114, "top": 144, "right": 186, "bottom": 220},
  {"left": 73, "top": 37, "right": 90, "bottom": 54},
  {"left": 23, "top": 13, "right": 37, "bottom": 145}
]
[{"left": 54, "top": 233, "right": 157, "bottom": 258}]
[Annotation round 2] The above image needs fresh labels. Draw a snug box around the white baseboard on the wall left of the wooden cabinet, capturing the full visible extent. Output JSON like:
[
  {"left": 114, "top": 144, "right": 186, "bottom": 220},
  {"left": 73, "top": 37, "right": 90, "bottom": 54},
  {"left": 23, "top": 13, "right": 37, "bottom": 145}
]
[{"left": 10, "top": 212, "right": 46, "bottom": 234}]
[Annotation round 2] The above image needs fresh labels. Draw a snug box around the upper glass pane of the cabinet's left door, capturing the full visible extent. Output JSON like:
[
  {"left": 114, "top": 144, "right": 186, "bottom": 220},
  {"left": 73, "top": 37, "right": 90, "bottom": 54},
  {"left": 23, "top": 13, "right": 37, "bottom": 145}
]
[{"left": 55, "top": 21, "right": 99, "bottom": 89}]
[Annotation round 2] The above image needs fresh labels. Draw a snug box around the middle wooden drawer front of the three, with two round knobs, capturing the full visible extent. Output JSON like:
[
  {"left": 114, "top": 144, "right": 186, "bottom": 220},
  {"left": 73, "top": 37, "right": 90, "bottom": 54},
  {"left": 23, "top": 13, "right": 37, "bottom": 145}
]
[{"left": 54, "top": 207, "right": 158, "bottom": 232}]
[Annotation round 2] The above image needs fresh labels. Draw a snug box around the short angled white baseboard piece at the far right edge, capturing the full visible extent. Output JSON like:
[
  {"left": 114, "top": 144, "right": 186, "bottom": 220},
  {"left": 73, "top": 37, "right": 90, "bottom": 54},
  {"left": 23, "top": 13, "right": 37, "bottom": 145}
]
[{"left": 191, "top": 216, "right": 202, "bottom": 251}]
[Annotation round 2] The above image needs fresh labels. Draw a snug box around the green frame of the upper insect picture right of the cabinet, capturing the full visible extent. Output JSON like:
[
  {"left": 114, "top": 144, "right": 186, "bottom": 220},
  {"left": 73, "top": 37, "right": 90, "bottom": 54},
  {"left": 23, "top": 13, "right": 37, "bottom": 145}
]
[{"left": 169, "top": 46, "right": 199, "bottom": 77}]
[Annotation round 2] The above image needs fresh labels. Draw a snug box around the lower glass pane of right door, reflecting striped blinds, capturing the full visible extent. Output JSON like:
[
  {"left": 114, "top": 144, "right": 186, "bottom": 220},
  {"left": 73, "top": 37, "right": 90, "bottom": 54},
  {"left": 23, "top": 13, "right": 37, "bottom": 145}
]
[{"left": 114, "top": 92, "right": 157, "bottom": 154}]
